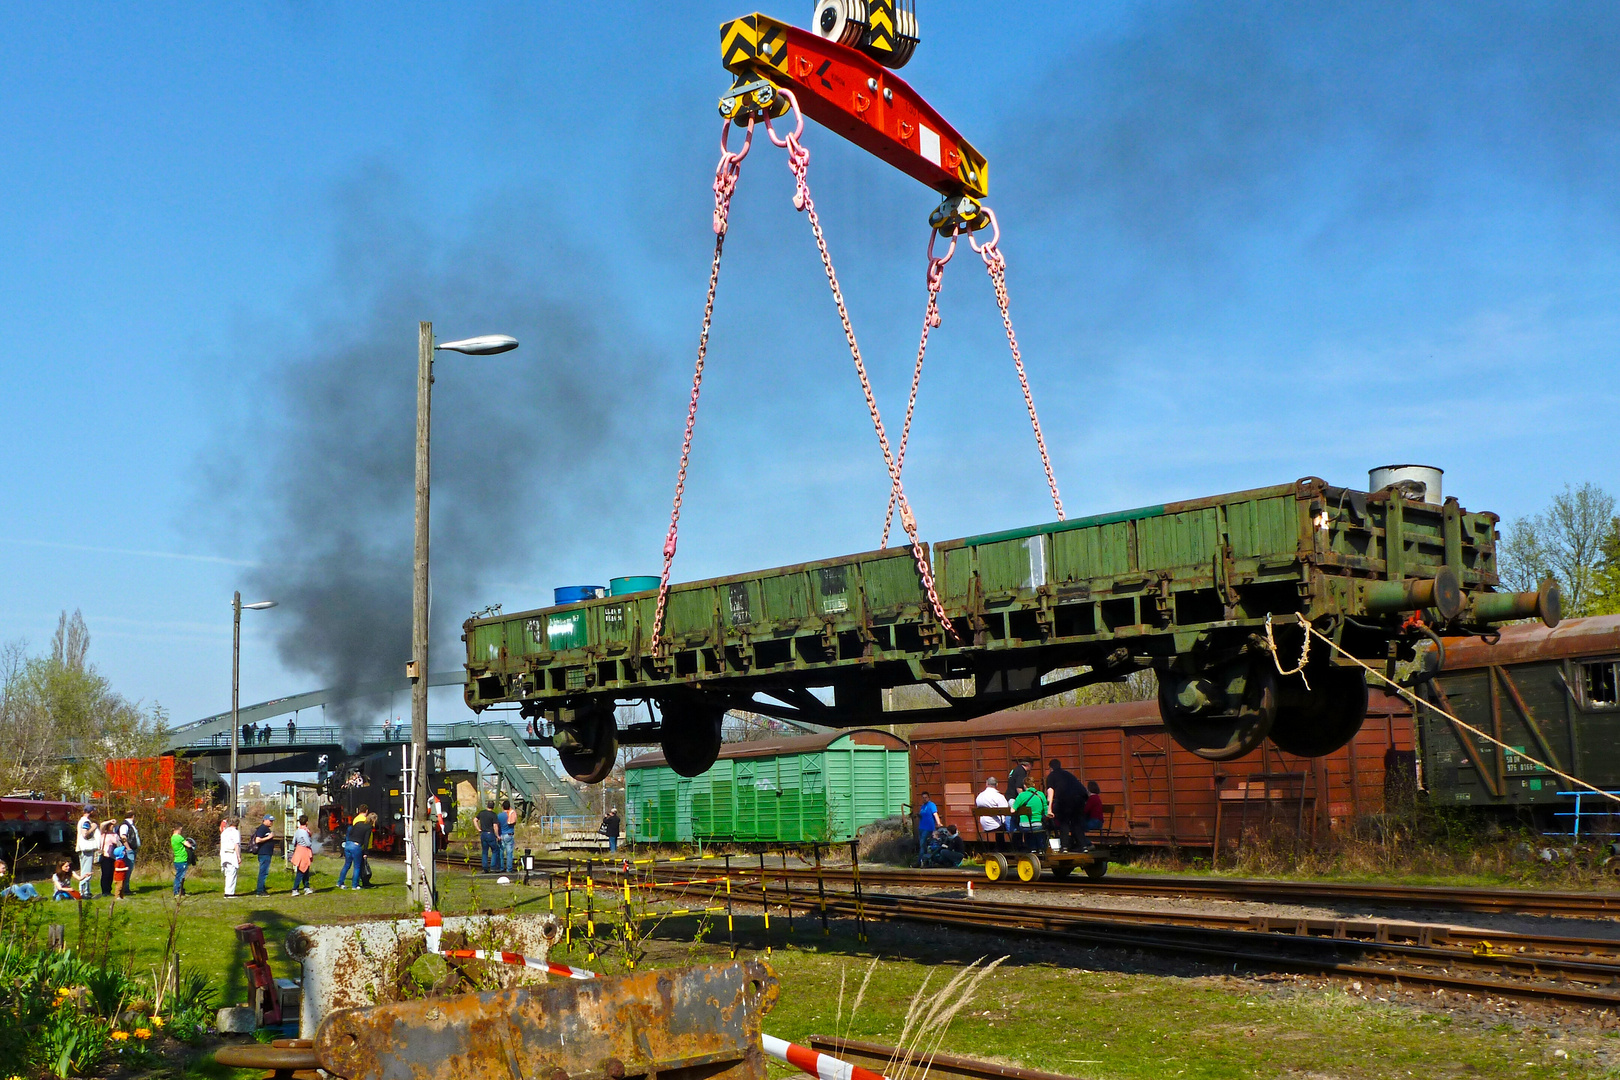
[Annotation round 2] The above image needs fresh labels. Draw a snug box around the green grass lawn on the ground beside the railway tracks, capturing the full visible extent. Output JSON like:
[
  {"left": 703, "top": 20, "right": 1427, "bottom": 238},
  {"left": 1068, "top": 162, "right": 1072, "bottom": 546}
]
[{"left": 31, "top": 857, "right": 1614, "bottom": 1080}]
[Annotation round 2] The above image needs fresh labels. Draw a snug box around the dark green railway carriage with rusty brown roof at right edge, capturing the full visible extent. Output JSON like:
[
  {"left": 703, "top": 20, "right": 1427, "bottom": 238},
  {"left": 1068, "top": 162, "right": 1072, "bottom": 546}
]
[{"left": 1414, "top": 615, "right": 1620, "bottom": 806}]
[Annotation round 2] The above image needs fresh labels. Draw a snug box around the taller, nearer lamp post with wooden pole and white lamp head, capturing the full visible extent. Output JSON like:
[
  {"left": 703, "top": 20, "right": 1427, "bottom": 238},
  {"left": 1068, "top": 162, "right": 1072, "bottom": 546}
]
[{"left": 405, "top": 322, "right": 517, "bottom": 912}]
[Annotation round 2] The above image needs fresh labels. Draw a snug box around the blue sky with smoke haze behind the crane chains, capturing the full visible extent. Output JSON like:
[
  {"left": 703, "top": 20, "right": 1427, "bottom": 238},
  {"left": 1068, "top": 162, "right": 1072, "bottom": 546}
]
[{"left": 0, "top": 0, "right": 1620, "bottom": 721}]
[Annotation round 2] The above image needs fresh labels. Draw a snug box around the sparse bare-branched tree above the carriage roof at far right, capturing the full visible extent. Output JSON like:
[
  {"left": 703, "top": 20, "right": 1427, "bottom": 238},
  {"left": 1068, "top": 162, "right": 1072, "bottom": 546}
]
[{"left": 1497, "top": 483, "right": 1620, "bottom": 617}]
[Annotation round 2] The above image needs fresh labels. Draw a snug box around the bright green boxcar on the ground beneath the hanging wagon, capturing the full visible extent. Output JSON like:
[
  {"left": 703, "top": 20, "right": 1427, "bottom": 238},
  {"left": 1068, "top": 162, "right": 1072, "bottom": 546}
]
[{"left": 624, "top": 729, "right": 910, "bottom": 844}]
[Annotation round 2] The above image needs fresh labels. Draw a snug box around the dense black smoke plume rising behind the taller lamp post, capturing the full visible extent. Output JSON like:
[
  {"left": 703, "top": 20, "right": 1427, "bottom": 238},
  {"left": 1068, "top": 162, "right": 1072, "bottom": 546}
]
[{"left": 211, "top": 172, "right": 656, "bottom": 727}]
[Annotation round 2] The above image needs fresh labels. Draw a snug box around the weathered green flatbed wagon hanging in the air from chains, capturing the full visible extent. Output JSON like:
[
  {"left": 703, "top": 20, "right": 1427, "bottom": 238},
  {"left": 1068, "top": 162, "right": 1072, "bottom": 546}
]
[{"left": 463, "top": 478, "right": 1557, "bottom": 780}]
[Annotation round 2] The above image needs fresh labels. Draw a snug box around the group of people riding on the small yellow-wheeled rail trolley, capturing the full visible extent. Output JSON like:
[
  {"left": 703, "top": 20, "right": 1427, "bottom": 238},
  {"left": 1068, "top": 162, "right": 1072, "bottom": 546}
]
[{"left": 917, "top": 758, "right": 1103, "bottom": 866}]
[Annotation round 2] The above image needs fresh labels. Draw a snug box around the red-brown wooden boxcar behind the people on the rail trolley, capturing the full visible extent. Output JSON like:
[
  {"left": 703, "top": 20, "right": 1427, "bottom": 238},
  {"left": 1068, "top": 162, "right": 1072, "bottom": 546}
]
[{"left": 910, "top": 691, "right": 1413, "bottom": 848}]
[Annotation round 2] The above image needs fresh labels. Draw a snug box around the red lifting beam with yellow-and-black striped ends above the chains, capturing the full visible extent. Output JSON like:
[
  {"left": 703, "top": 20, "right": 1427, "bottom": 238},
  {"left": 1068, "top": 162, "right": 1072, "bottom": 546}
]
[{"left": 719, "top": 13, "right": 990, "bottom": 199}]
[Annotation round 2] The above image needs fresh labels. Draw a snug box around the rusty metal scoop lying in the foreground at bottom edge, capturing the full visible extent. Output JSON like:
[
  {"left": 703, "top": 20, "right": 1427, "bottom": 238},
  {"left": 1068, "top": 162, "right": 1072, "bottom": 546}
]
[{"left": 214, "top": 960, "right": 778, "bottom": 1080}]
